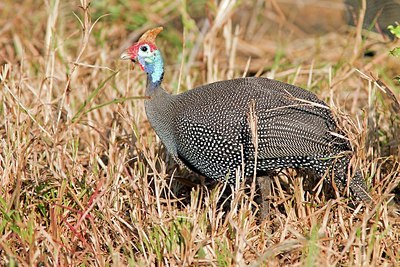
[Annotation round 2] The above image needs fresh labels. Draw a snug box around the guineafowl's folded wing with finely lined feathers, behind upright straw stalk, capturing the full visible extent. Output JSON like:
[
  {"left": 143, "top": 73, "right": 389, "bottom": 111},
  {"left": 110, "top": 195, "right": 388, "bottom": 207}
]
[{"left": 244, "top": 81, "right": 351, "bottom": 159}]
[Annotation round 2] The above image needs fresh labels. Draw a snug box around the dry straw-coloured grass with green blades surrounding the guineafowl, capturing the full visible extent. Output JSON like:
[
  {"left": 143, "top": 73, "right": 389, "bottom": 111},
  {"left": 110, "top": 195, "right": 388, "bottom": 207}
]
[{"left": 0, "top": 0, "right": 400, "bottom": 266}]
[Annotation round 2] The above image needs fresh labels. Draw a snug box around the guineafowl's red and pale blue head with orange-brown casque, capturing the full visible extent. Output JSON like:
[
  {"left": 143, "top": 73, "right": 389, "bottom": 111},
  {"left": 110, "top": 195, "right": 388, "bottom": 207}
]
[{"left": 121, "top": 27, "right": 163, "bottom": 74}]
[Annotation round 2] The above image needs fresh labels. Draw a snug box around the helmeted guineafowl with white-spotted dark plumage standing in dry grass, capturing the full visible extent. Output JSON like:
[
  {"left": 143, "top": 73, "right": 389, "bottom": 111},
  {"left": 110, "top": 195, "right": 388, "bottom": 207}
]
[{"left": 120, "top": 27, "right": 371, "bottom": 207}]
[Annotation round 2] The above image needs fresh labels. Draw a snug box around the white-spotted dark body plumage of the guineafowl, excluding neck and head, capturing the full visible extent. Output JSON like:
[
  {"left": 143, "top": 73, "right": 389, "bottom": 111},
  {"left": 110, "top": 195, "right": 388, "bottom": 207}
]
[{"left": 161, "top": 78, "right": 350, "bottom": 179}]
